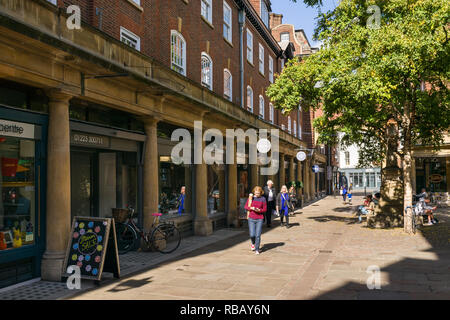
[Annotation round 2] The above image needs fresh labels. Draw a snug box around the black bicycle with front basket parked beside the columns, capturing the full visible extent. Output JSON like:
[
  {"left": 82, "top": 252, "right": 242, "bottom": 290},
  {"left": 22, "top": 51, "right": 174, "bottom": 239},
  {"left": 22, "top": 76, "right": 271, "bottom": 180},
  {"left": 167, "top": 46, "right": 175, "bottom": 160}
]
[{"left": 115, "top": 207, "right": 181, "bottom": 254}]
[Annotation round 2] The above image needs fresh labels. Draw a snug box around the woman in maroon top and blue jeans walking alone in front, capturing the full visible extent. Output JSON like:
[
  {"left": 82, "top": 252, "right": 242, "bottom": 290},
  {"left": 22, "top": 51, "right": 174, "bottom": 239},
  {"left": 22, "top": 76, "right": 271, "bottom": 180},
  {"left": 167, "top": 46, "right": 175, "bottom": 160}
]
[{"left": 245, "top": 186, "right": 267, "bottom": 254}]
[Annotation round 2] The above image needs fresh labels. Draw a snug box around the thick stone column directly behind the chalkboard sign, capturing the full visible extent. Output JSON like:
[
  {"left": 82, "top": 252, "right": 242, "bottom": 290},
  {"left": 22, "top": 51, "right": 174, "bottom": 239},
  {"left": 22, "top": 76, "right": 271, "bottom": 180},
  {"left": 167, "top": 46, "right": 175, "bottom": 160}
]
[{"left": 41, "top": 90, "right": 71, "bottom": 281}]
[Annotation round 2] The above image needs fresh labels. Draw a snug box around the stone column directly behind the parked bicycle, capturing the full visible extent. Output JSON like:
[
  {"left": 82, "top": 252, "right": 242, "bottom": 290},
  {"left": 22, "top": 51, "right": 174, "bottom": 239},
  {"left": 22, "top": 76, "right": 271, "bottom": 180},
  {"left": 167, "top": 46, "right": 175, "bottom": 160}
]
[{"left": 142, "top": 118, "right": 161, "bottom": 230}]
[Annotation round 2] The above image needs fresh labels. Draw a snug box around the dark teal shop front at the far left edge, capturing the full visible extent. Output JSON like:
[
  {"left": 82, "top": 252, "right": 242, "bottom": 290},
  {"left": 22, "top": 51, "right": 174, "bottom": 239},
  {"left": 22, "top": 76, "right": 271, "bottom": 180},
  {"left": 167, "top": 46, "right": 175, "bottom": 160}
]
[{"left": 0, "top": 105, "right": 47, "bottom": 288}]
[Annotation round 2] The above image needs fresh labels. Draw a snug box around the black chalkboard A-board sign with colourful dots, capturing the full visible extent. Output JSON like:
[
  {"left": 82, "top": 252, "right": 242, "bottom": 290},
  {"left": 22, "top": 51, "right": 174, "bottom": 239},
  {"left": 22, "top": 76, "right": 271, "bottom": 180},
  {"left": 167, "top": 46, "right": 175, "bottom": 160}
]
[{"left": 63, "top": 217, "right": 120, "bottom": 281}]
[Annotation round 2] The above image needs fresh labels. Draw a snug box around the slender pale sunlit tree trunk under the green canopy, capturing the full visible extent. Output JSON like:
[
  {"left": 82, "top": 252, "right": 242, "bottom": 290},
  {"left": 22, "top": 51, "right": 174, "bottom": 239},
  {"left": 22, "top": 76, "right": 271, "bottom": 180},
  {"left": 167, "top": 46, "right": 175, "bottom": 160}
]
[{"left": 402, "top": 109, "right": 413, "bottom": 234}]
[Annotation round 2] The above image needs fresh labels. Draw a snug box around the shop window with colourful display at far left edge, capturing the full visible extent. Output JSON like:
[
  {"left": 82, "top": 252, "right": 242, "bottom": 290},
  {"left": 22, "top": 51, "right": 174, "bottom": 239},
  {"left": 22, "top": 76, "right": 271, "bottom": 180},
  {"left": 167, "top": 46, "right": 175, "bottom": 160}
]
[{"left": 0, "top": 136, "right": 36, "bottom": 250}]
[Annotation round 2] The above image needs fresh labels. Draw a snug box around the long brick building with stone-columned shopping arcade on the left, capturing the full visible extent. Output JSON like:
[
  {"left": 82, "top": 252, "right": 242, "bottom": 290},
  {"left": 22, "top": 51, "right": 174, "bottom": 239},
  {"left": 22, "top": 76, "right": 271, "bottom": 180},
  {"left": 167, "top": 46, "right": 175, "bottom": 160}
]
[{"left": 0, "top": 0, "right": 311, "bottom": 287}]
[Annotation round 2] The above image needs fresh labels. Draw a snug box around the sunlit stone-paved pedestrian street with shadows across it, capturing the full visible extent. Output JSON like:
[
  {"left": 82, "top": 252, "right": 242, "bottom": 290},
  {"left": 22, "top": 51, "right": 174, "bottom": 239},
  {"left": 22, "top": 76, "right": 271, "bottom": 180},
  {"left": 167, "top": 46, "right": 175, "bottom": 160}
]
[{"left": 65, "top": 196, "right": 450, "bottom": 300}]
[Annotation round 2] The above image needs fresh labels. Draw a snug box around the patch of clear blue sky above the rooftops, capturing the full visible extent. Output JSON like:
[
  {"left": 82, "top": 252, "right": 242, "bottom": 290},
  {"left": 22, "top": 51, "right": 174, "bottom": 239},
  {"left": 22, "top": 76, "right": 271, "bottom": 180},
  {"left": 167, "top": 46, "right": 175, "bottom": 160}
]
[{"left": 271, "top": 0, "right": 339, "bottom": 47}]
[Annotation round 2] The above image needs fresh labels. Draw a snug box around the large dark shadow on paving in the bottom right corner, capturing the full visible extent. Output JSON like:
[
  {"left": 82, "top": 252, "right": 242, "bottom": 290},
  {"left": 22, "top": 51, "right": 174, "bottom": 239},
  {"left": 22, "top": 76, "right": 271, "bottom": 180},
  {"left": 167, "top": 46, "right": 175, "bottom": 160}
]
[{"left": 315, "top": 209, "right": 450, "bottom": 300}]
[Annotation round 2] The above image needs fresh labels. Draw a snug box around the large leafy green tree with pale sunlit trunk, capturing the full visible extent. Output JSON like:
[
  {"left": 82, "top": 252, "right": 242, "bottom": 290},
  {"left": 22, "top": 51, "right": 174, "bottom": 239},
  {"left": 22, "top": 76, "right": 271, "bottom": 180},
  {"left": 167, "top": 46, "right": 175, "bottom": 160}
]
[{"left": 267, "top": 0, "right": 450, "bottom": 233}]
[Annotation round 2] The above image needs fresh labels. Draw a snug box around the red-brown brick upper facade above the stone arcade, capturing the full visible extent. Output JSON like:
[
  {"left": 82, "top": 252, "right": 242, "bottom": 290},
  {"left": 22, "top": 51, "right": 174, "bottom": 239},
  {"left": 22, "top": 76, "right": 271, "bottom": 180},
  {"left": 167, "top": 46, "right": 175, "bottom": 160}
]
[{"left": 53, "top": 0, "right": 299, "bottom": 133}]
